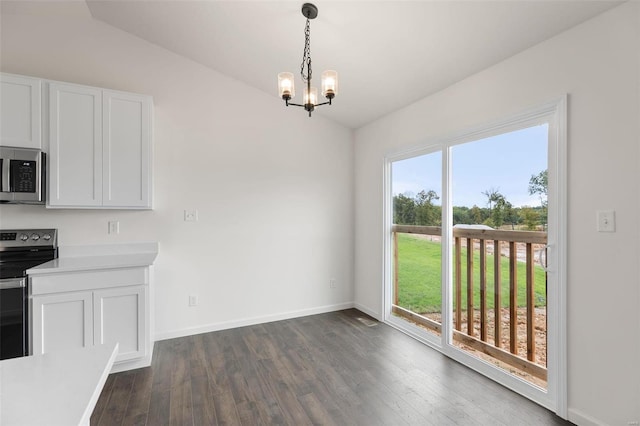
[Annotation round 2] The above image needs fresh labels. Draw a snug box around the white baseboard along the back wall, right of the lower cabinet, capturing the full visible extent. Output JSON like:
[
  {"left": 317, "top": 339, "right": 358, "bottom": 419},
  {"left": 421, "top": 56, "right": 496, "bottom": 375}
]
[{"left": 154, "top": 302, "right": 356, "bottom": 341}]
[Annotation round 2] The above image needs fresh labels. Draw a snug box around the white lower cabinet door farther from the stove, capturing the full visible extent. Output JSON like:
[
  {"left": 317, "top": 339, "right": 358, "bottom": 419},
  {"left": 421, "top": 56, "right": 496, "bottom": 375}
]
[{"left": 93, "top": 286, "right": 147, "bottom": 362}]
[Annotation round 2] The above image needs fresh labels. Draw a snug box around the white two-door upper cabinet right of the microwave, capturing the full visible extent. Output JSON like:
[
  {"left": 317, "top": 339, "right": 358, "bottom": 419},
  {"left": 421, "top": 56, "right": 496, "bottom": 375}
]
[{"left": 47, "top": 82, "right": 153, "bottom": 209}]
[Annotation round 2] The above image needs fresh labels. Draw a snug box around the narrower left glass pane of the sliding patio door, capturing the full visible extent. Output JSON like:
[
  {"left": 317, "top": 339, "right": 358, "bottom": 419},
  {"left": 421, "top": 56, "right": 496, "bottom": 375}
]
[{"left": 391, "top": 151, "right": 442, "bottom": 336}]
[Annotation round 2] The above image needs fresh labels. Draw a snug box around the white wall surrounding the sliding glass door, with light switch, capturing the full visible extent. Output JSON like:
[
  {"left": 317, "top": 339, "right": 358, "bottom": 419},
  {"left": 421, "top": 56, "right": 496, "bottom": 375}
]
[{"left": 355, "top": 2, "right": 640, "bottom": 425}]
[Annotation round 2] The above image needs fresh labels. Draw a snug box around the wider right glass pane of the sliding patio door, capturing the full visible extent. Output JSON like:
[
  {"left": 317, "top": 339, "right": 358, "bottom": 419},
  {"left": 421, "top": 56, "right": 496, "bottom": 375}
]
[{"left": 450, "top": 124, "right": 549, "bottom": 388}]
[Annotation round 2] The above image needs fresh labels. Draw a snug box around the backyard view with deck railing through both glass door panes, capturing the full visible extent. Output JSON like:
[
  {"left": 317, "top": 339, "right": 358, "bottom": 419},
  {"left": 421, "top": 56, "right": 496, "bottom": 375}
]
[{"left": 392, "top": 125, "right": 547, "bottom": 387}]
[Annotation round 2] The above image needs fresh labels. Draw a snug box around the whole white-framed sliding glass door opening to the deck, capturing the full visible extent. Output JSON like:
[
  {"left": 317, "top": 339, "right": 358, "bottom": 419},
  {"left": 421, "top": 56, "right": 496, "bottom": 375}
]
[{"left": 385, "top": 102, "right": 566, "bottom": 415}]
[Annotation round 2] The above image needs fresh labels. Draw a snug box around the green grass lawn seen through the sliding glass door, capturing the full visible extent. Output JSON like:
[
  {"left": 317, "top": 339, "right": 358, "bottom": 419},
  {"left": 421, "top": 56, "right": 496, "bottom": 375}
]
[{"left": 398, "top": 234, "right": 546, "bottom": 314}]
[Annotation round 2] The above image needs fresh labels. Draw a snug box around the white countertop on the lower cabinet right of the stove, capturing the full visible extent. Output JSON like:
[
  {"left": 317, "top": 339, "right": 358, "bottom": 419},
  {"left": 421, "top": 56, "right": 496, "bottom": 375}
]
[{"left": 27, "top": 243, "right": 158, "bottom": 276}]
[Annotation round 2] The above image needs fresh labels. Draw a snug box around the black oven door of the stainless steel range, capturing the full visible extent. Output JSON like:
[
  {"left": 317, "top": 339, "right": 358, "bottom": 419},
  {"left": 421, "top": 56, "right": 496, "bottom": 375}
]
[{"left": 0, "top": 277, "right": 29, "bottom": 360}]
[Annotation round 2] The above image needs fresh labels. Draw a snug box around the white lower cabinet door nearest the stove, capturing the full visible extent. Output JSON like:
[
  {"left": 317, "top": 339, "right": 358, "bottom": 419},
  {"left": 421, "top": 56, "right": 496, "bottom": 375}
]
[{"left": 32, "top": 292, "right": 93, "bottom": 355}]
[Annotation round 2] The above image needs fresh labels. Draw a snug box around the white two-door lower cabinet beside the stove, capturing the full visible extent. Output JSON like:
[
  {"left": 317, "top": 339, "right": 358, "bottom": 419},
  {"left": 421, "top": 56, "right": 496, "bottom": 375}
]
[{"left": 30, "top": 267, "right": 151, "bottom": 371}]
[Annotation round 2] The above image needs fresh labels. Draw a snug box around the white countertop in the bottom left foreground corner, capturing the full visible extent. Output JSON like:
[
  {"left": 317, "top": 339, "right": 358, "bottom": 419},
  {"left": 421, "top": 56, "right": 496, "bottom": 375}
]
[{"left": 0, "top": 344, "right": 118, "bottom": 426}]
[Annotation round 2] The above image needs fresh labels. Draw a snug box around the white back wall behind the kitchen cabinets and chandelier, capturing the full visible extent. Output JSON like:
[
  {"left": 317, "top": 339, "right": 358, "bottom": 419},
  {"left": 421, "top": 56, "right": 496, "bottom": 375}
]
[{"left": 0, "top": 2, "right": 354, "bottom": 338}]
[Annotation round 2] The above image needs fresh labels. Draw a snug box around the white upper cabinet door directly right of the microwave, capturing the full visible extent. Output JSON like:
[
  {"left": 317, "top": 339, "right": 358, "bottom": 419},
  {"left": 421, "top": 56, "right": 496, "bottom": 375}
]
[{"left": 49, "top": 83, "right": 102, "bottom": 207}]
